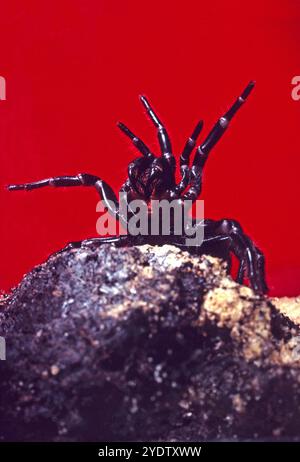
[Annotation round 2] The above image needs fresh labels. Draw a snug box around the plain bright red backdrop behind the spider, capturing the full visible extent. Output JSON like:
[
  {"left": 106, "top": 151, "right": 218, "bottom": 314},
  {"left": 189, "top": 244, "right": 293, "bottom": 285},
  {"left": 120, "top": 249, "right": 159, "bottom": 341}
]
[{"left": 0, "top": 0, "right": 300, "bottom": 295}]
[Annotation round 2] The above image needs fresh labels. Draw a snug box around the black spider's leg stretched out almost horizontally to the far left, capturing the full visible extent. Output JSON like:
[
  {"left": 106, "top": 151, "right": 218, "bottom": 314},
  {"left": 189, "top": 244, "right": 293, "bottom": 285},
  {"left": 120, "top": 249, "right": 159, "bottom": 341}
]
[{"left": 8, "top": 173, "right": 127, "bottom": 224}]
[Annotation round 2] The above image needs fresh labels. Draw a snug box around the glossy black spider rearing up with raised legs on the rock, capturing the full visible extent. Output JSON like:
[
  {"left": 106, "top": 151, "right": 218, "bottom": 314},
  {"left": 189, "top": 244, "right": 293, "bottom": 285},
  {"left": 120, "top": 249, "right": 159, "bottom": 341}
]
[{"left": 8, "top": 82, "right": 268, "bottom": 293}]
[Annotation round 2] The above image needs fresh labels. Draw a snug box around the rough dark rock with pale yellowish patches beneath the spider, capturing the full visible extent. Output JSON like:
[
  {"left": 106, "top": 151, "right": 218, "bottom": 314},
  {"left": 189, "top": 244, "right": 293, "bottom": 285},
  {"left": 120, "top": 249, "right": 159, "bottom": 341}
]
[{"left": 0, "top": 245, "right": 300, "bottom": 441}]
